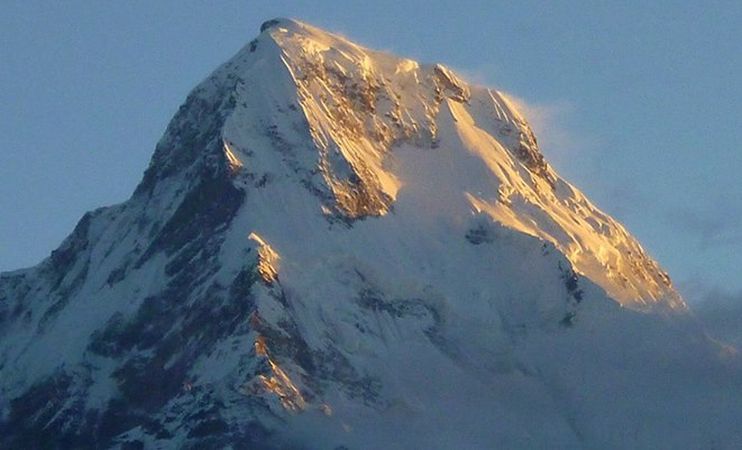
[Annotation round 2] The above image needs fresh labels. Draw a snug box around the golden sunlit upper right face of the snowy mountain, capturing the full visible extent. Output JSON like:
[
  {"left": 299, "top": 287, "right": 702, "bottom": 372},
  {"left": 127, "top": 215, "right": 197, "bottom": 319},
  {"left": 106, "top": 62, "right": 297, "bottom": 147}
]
[{"left": 224, "top": 20, "right": 685, "bottom": 310}]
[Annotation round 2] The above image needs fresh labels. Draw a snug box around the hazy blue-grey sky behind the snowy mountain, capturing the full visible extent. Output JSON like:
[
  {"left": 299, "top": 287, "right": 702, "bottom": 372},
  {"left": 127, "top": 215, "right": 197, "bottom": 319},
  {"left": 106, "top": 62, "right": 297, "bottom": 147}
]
[{"left": 0, "top": 0, "right": 742, "bottom": 302}]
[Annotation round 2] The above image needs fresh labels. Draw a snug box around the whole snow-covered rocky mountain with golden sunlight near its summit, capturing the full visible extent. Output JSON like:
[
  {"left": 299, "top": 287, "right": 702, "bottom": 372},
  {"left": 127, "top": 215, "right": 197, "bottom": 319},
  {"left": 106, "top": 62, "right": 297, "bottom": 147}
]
[{"left": 0, "top": 19, "right": 742, "bottom": 449}]
